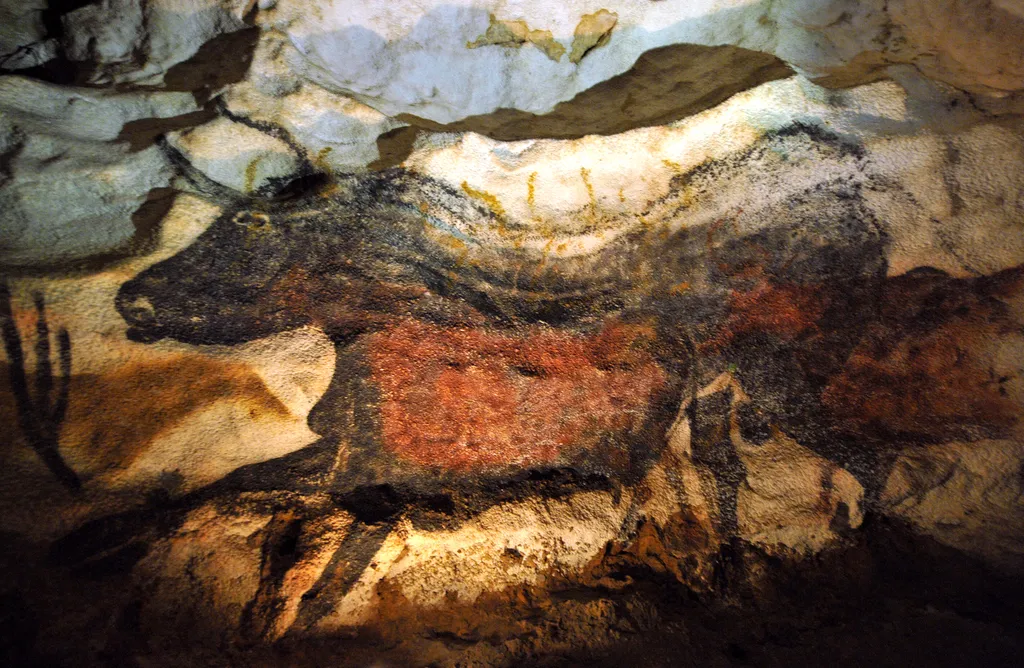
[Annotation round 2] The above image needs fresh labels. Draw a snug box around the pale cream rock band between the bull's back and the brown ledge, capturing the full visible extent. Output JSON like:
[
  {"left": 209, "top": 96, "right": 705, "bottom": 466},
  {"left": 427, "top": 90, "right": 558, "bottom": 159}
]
[{"left": 406, "top": 78, "right": 1024, "bottom": 276}]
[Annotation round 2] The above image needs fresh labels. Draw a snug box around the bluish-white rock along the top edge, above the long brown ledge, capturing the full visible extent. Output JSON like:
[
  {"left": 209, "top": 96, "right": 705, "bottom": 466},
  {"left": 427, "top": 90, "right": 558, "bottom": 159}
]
[{"left": 268, "top": 0, "right": 1024, "bottom": 123}]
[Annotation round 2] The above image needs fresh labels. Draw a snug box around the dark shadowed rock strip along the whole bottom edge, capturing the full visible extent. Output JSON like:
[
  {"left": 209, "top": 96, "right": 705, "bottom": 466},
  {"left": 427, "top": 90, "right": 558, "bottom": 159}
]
[{"left": 9, "top": 516, "right": 1007, "bottom": 668}]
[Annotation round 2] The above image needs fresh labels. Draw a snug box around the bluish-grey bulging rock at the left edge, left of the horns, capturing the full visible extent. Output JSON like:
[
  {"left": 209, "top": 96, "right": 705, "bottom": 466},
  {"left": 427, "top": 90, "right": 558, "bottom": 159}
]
[{"left": 0, "top": 76, "right": 198, "bottom": 265}]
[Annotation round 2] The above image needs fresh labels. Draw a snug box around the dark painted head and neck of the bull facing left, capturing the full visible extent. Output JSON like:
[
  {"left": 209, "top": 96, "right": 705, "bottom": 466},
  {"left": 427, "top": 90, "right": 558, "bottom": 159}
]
[{"left": 117, "top": 170, "right": 460, "bottom": 344}]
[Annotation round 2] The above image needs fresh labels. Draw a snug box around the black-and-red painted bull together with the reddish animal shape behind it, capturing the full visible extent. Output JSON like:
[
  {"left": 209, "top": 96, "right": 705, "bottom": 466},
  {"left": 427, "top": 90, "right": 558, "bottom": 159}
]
[{"left": 88, "top": 125, "right": 1022, "bottom": 615}]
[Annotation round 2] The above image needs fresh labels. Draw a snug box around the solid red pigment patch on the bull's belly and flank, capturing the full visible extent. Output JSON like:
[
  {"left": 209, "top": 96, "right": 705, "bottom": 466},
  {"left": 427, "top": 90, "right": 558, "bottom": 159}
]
[{"left": 368, "top": 321, "right": 668, "bottom": 470}]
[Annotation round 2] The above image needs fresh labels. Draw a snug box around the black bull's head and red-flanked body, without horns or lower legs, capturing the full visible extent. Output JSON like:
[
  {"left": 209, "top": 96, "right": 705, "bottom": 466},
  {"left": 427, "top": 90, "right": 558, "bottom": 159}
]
[{"left": 117, "top": 127, "right": 885, "bottom": 514}]
